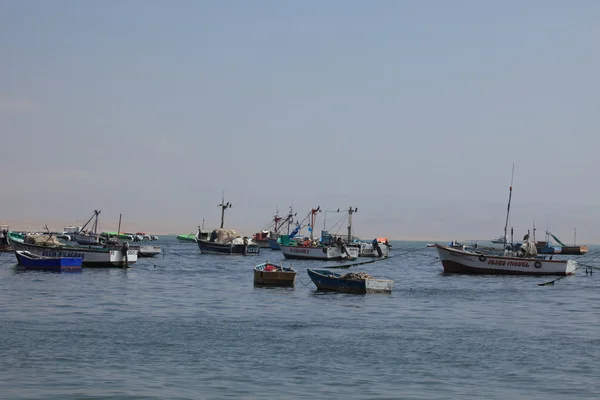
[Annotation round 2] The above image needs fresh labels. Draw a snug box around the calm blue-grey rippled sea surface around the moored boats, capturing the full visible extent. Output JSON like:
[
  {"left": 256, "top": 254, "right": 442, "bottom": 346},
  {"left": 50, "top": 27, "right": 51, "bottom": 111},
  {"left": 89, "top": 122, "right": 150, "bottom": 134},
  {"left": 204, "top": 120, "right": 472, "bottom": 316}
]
[{"left": 0, "top": 238, "right": 600, "bottom": 400}]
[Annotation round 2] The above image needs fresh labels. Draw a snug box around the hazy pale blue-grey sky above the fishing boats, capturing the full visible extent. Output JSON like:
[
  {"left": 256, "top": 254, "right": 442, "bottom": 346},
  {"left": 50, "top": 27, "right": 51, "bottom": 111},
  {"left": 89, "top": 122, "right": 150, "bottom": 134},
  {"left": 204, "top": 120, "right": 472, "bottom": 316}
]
[{"left": 0, "top": 0, "right": 600, "bottom": 243}]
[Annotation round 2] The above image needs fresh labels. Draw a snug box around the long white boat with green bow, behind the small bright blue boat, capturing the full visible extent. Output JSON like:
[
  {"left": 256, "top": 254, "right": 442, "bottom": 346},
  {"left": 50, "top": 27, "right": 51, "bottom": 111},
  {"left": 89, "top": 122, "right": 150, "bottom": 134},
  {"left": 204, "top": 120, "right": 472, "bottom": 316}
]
[{"left": 8, "top": 232, "right": 138, "bottom": 268}]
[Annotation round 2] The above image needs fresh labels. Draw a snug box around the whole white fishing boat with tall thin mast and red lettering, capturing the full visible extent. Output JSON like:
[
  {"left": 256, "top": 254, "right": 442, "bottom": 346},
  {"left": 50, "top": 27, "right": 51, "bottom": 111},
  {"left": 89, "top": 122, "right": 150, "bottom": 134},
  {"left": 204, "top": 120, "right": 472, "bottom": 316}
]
[{"left": 435, "top": 165, "right": 577, "bottom": 275}]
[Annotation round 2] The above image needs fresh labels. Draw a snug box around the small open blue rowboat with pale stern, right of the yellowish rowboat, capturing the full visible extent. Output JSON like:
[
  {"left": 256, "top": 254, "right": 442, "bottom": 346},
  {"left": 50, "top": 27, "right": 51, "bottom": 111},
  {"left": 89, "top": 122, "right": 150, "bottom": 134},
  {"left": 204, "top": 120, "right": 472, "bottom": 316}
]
[{"left": 306, "top": 268, "right": 394, "bottom": 294}]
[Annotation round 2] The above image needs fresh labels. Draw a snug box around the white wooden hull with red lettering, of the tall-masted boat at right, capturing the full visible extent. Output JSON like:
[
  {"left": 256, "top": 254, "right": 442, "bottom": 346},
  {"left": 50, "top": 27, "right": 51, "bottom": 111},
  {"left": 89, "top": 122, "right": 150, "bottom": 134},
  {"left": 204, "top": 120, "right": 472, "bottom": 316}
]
[{"left": 435, "top": 244, "right": 577, "bottom": 275}]
